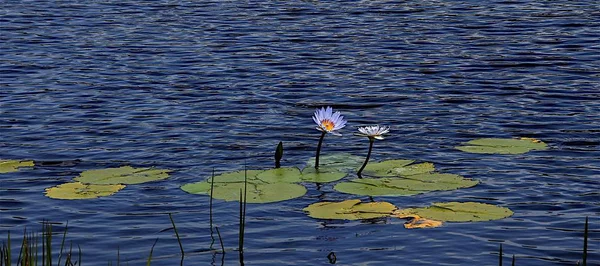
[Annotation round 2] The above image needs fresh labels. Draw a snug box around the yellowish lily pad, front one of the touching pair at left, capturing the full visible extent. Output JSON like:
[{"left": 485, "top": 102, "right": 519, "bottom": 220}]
[{"left": 46, "top": 182, "right": 125, "bottom": 200}]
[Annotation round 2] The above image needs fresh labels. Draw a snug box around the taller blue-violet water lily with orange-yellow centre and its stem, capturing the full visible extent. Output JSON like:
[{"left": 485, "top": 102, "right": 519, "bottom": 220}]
[{"left": 313, "top": 106, "right": 346, "bottom": 169}]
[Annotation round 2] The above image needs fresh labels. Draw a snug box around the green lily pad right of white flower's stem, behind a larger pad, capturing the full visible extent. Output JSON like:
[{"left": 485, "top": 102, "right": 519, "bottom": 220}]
[{"left": 363, "top": 160, "right": 435, "bottom": 176}]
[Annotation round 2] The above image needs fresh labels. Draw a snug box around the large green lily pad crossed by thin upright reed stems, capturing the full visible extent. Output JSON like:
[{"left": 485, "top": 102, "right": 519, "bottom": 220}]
[{"left": 181, "top": 181, "right": 306, "bottom": 203}]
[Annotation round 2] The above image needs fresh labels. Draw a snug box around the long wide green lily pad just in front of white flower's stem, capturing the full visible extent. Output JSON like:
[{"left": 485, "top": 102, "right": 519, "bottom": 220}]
[{"left": 334, "top": 173, "right": 478, "bottom": 196}]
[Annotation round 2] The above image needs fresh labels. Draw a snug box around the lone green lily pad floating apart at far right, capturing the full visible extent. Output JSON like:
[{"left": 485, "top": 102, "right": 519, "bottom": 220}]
[{"left": 456, "top": 138, "right": 548, "bottom": 154}]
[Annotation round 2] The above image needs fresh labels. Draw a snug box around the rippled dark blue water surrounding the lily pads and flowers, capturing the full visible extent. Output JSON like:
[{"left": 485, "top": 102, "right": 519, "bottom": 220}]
[{"left": 0, "top": 0, "right": 600, "bottom": 265}]
